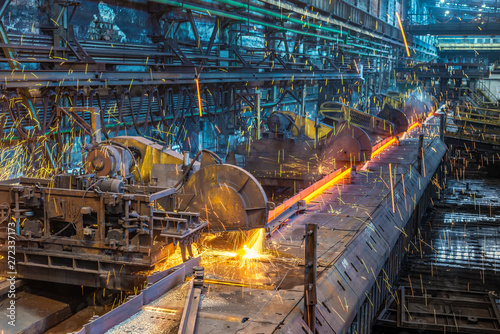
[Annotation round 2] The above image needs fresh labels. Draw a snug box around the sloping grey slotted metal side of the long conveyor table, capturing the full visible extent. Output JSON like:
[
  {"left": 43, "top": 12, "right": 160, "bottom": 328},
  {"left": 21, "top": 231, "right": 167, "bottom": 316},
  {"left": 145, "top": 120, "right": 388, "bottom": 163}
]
[{"left": 280, "top": 137, "right": 447, "bottom": 334}]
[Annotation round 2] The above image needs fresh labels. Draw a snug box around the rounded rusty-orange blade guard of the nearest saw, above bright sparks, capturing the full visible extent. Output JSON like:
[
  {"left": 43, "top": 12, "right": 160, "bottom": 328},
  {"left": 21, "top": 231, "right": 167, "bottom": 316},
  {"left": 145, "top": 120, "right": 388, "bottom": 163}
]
[{"left": 177, "top": 163, "right": 268, "bottom": 232}]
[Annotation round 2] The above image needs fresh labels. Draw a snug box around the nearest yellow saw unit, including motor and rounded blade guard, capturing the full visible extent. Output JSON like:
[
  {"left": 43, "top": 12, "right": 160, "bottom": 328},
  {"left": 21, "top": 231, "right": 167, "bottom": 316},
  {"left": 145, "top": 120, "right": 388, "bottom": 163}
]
[{"left": 86, "top": 136, "right": 268, "bottom": 232}]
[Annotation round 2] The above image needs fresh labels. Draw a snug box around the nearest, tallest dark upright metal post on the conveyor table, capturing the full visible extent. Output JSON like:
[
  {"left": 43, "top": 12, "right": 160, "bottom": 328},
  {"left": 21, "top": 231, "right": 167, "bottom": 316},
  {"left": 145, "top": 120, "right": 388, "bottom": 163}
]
[{"left": 304, "top": 224, "right": 318, "bottom": 333}]
